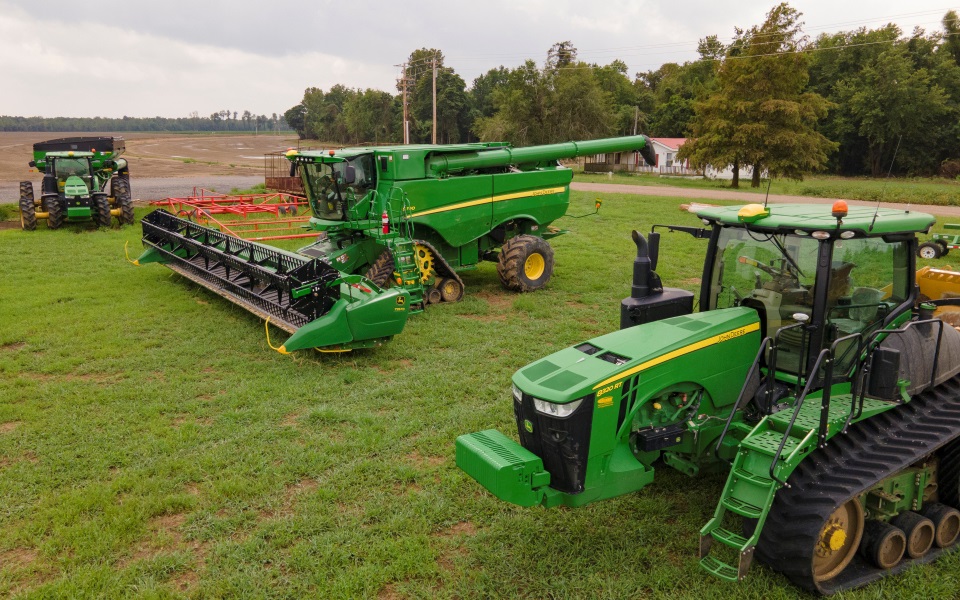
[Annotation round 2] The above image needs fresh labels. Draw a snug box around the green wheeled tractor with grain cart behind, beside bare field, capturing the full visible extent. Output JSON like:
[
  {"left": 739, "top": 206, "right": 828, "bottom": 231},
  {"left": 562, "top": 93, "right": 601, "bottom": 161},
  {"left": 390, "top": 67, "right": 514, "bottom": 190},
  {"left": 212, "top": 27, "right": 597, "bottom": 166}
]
[{"left": 20, "top": 137, "right": 134, "bottom": 231}]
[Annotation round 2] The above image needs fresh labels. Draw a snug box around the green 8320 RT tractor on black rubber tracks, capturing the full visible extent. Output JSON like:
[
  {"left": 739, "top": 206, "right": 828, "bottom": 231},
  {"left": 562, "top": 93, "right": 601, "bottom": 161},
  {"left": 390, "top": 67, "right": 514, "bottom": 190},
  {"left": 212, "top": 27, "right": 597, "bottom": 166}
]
[{"left": 456, "top": 203, "right": 960, "bottom": 594}]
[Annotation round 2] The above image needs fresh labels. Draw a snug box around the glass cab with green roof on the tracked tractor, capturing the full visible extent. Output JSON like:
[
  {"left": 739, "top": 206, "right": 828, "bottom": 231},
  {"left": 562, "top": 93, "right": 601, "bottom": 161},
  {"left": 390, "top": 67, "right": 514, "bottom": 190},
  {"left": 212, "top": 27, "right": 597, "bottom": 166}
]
[{"left": 698, "top": 203, "right": 932, "bottom": 376}]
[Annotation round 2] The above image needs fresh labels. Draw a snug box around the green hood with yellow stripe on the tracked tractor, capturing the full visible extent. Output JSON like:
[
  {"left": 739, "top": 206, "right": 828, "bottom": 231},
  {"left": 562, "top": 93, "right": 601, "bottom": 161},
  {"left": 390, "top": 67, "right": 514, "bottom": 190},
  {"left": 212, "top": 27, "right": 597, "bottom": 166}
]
[{"left": 513, "top": 308, "right": 760, "bottom": 403}]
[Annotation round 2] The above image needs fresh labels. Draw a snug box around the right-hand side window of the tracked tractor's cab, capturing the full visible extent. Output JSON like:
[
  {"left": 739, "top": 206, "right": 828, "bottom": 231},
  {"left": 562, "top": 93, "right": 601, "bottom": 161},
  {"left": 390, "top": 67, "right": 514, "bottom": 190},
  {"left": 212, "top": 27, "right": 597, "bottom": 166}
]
[{"left": 826, "top": 238, "right": 910, "bottom": 371}]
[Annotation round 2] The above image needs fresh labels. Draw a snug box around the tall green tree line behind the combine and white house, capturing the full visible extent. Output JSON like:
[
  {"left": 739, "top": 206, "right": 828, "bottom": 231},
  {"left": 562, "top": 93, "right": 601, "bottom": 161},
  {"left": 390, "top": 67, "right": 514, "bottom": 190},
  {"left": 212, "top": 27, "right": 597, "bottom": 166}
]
[{"left": 284, "top": 3, "right": 960, "bottom": 184}]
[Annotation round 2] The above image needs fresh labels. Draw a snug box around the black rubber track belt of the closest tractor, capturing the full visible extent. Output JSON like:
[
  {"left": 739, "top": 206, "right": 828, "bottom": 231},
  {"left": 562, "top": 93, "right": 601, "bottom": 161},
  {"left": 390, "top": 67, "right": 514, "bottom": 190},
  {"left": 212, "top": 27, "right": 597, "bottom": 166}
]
[{"left": 757, "top": 376, "right": 960, "bottom": 594}]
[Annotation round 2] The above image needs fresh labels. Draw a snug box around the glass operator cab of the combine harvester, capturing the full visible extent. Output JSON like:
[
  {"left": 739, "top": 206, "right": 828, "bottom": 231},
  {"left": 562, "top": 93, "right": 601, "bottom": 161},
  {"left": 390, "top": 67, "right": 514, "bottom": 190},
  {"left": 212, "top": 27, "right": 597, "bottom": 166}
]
[{"left": 288, "top": 151, "right": 379, "bottom": 229}]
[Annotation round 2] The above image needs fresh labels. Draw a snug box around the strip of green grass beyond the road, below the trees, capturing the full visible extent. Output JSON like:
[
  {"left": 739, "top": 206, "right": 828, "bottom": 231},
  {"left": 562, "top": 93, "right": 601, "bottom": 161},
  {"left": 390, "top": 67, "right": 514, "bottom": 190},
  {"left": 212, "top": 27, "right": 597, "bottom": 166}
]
[{"left": 575, "top": 172, "right": 960, "bottom": 206}]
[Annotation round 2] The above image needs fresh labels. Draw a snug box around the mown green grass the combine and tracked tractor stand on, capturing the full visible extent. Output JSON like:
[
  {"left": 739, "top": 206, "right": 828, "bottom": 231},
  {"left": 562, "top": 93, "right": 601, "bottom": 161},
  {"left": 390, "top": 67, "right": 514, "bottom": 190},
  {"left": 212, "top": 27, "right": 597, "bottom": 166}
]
[{"left": 0, "top": 193, "right": 960, "bottom": 599}]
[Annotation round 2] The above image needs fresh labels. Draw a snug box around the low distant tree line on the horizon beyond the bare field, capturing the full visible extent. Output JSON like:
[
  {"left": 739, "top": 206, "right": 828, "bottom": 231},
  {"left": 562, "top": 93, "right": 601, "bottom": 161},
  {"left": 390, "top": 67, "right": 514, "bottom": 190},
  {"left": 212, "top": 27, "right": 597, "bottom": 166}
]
[{"left": 0, "top": 110, "right": 289, "bottom": 133}]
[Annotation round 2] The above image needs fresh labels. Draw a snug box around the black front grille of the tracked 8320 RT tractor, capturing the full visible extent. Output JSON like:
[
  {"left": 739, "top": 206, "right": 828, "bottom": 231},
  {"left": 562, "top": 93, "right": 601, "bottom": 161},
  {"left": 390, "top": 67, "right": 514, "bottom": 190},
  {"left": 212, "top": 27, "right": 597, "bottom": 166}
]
[{"left": 513, "top": 394, "right": 593, "bottom": 494}]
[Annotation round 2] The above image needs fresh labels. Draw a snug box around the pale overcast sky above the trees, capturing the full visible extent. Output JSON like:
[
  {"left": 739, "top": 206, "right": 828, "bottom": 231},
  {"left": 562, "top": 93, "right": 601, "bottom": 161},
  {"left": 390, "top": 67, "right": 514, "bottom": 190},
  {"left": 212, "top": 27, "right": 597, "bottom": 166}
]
[{"left": 0, "top": 0, "right": 960, "bottom": 117}]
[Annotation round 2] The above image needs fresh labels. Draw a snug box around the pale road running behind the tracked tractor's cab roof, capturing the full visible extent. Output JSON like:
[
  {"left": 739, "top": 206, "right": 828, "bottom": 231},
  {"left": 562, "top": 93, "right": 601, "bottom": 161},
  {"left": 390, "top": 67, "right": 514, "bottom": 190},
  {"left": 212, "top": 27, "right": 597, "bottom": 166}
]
[{"left": 570, "top": 181, "right": 960, "bottom": 217}]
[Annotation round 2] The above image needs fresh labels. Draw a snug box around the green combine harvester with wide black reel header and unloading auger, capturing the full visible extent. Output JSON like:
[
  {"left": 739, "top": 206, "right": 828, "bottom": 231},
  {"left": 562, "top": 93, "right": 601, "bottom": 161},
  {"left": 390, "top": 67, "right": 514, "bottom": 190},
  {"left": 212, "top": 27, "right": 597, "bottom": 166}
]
[{"left": 137, "top": 135, "right": 655, "bottom": 352}]
